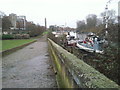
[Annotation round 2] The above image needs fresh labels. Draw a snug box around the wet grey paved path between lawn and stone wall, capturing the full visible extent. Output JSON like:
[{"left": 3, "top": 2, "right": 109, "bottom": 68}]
[{"left": 2, "top": 36, "right": 57, "bottom": 88}]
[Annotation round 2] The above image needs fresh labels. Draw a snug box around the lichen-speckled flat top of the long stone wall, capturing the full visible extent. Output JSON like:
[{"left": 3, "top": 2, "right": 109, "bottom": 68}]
[{"left": 48, "top": 38, "right": 120, "bottom": 89}]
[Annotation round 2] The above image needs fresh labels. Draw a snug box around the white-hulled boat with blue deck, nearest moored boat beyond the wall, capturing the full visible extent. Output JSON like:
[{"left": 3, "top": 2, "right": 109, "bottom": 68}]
[{"left": 76, "top": 34, "right": 103, "bottom": 54}]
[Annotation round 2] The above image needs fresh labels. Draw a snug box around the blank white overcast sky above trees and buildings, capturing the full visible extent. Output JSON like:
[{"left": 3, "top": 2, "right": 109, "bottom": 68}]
[{"left": 0, "top": 0, "right": 120, "bottom": 27}]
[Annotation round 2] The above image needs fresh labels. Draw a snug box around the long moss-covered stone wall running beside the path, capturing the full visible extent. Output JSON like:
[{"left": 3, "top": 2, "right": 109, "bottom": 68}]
[{"left": 48, "top": 39, "right": 120, "bottom": 88}]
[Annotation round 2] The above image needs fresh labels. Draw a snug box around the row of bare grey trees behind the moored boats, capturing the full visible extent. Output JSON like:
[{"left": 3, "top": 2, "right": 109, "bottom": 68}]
[{"left": 77, "top": 10, "right": 117, "bottom": 33}]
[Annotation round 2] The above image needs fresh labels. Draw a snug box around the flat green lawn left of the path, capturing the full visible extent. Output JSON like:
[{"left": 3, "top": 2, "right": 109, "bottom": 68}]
[{"left": 0, "top": 39, "right": 35, "bottom": 51}]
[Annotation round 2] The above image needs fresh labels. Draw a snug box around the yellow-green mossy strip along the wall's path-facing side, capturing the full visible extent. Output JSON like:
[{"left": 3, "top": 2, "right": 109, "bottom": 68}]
[{"left": 48, "top": 40, "right": 73, "bottom": 88}]
